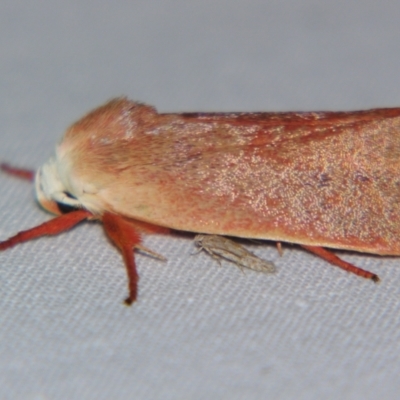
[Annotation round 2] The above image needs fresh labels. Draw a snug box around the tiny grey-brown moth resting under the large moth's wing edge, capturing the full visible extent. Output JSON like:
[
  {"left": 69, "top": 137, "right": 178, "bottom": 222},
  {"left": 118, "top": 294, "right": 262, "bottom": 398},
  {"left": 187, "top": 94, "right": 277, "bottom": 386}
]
[{"left": 194, "top": 234, "right": 275, "bottom": 273}]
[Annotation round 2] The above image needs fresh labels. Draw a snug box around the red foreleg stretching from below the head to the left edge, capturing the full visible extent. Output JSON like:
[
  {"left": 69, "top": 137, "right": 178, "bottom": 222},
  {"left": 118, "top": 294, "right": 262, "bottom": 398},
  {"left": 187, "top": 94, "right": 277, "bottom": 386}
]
[{"left": 0, "top": 210, "right": 92, "bottom": 250}]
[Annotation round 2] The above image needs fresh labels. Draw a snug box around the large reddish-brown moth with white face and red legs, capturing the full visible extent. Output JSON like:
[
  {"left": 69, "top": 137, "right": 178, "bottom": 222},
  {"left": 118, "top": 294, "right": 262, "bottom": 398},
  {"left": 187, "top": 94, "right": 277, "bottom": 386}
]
[{"left": 0, "top": 97, "right": 400, "bottom": 304}]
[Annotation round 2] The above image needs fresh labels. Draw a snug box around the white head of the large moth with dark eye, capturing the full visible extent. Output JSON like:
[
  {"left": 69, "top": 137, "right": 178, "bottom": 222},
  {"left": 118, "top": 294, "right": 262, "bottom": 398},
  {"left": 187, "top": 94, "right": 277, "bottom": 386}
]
[{"left": 35, "top": 158, "right": 81, "bottom": 215}]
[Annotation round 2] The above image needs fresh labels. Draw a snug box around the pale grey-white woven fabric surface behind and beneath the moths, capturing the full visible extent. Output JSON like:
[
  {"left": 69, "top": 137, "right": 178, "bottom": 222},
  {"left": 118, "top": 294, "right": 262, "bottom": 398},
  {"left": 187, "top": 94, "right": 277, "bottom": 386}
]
[{"left": 0, "top": 0, "right": 400, "bottom": 400}]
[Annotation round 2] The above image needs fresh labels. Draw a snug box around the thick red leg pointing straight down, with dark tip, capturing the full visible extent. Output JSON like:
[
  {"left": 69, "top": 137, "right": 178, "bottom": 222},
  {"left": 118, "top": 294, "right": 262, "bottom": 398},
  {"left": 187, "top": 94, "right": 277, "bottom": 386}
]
[{"left": 103, "top": 212, "right": 141, "bottom": 305}]
